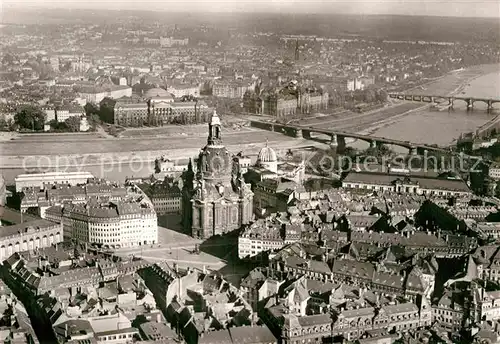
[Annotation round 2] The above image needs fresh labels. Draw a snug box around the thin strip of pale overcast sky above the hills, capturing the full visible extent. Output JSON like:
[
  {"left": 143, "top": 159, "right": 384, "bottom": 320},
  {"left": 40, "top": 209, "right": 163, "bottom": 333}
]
[{"left": 0, "top": 0, "right": 500, "bottom": 18}]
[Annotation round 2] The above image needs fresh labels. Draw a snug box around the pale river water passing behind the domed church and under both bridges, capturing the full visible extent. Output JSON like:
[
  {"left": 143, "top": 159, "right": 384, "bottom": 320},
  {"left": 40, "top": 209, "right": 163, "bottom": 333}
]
[{"left": 0, "top": 65, "right": 500, "bottom": 179}]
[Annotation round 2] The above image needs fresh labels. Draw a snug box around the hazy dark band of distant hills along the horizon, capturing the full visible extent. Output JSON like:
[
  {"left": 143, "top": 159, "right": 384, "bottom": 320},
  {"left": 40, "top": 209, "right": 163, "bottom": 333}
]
[{"left": 2, "top": 8, "right": 500, "bottom": 43}]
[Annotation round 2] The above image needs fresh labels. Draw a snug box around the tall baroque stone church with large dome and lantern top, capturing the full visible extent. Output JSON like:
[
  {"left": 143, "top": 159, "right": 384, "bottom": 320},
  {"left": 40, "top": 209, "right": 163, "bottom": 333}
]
[{"left": 182, "top": 111, "right": 253, "bottom": 240}]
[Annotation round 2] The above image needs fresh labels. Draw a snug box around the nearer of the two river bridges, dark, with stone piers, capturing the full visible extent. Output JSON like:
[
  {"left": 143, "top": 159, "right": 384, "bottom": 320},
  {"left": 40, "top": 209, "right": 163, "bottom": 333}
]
[{"left": 251, "top": 121, "right": 450, "bottom": 155}]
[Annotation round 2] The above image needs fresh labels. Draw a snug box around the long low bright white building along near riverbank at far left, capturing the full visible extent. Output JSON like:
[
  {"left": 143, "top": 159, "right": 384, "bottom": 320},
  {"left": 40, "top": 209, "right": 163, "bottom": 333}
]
[{"left": 15, "top": 171, "right": 94, "bottom": 192}]
